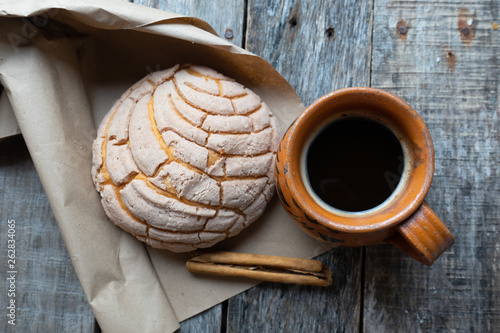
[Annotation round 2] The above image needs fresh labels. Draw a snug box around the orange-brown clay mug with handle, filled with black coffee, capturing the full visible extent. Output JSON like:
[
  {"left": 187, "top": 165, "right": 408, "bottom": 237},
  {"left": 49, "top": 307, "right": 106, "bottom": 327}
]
[{"left": 276, "top": 88, "right": 454, "bottom": 265}]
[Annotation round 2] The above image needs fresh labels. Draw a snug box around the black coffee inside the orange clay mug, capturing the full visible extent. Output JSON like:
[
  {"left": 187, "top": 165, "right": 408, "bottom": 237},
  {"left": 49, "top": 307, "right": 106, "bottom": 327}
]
[{"left": 306, "top": 117, "right": 404, "bottom": 212}]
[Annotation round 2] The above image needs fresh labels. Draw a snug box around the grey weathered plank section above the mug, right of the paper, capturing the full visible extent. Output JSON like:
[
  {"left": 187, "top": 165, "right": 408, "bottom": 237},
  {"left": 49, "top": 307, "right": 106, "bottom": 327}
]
[{"left": 245, "top": 0, "right": 373, "bottom": 106}]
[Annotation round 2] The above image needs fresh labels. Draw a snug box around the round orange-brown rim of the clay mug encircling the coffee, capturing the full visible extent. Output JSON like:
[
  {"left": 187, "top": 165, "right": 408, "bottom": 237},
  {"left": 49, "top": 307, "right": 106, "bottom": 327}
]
[{"left": 285, "top": 87, "right": 434, "bottom": 233}]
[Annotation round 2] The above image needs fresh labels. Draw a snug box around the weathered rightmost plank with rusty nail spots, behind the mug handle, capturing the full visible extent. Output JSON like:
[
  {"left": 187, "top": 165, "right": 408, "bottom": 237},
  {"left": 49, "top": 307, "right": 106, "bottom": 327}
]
[{"left": 363, "top": 0, "right": 500, "bottom": 332}]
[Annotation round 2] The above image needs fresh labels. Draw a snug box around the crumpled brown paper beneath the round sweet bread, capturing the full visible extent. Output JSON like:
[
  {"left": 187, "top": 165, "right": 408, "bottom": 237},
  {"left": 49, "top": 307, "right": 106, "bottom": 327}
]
[{"left": 0, "top": 0, "right": 328, "bottom": 332}]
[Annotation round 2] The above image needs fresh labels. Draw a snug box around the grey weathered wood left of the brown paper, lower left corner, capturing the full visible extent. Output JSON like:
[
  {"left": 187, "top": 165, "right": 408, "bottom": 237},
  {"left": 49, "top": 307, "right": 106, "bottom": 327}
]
[{"left": 0, "top": 136, "right": 95, "bottom": 332}]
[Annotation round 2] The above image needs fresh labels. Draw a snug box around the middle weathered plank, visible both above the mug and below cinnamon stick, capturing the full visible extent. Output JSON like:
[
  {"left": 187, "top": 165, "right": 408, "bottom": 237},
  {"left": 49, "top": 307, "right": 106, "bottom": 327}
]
[{"left": 228, "top": 0, "right": 372, "bottom": 332}]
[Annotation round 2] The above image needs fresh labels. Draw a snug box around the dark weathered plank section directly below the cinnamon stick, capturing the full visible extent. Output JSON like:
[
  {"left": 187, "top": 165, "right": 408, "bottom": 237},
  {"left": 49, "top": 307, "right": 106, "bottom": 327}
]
[{"left": 227, "top": 248, "right": 362, "bottom": 332}]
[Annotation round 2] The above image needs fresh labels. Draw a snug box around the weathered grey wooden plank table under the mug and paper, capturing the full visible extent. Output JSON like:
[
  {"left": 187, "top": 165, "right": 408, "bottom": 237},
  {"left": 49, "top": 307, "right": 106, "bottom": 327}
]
[{"left": 0, "top": 0, "right": 500, "bottom": 332}]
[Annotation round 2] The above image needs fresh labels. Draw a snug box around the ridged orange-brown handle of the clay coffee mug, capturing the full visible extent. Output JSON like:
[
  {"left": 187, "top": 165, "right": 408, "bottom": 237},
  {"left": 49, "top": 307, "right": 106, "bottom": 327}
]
[{"left": 387, "top": 201, "right": 455, "bottom": 266}]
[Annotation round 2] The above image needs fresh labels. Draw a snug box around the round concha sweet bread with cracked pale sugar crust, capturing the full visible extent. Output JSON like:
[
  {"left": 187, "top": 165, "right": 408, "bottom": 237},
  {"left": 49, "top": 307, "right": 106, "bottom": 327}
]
[{"left": 92, "top": 65, "right": 280, "bottom": 252}]
